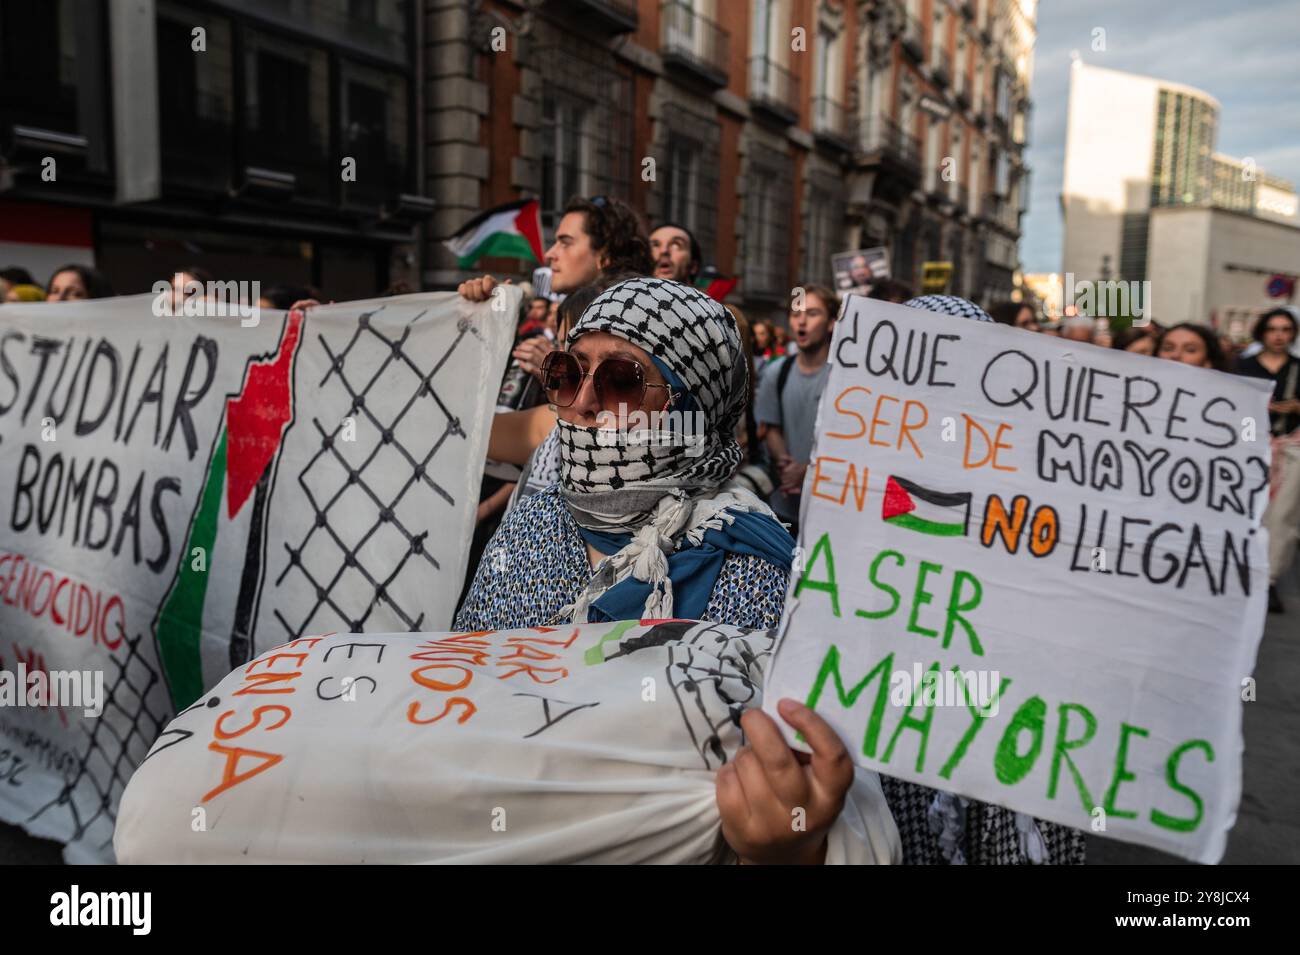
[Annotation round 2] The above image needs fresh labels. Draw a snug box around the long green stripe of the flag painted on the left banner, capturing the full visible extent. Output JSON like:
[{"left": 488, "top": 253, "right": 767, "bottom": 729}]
[{"left": 159, "top": 429, "right": 226, "bottom": 711}]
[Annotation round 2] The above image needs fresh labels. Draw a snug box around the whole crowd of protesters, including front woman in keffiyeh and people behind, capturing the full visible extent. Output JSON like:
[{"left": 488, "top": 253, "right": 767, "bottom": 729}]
[{"left": 0, "top": 196, "right": 1300, "bottom": 863}]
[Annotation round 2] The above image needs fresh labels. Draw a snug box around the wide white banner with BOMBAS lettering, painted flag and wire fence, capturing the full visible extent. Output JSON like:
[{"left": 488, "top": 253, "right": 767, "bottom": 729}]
[{"left": 0, "top": 290, "right": 519, "bottom": 860}]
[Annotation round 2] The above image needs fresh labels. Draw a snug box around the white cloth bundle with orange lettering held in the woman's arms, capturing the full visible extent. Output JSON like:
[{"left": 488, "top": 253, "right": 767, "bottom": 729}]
[{"left": 114, "top": 620, "right": 898, "bottom": 863}]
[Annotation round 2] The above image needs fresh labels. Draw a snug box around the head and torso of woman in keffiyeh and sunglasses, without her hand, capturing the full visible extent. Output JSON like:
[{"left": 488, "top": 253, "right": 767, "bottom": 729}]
[{"left": 456, "top": 278, "right": 794, "bottom": 629}]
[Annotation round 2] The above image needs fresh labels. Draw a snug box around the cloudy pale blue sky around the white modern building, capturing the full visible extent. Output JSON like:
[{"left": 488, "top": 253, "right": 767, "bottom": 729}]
[{"left": 1021, "top": 0, "right": 1300, "bottom": 272}]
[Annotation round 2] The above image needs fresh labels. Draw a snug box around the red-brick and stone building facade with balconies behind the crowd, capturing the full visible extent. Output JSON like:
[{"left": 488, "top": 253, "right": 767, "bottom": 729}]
[{"left": 421, "top": 0, "right": 1035, "bottom": 316}]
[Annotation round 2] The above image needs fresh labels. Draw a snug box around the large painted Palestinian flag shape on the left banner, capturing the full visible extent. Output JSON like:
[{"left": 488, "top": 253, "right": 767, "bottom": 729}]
[{"left": 155, "top": 312, "right": 303, "bottom": 712}]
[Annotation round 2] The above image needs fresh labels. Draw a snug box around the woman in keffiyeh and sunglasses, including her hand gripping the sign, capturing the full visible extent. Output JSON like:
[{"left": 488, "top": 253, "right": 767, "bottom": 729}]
[{"left": 455, "top": 278, "right": 898, "bottom": 864}]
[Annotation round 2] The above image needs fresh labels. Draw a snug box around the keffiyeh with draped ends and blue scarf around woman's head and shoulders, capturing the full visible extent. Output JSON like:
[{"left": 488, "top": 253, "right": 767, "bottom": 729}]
[{"left": 556, "top": 272, "right": 794, "bottom": 622}]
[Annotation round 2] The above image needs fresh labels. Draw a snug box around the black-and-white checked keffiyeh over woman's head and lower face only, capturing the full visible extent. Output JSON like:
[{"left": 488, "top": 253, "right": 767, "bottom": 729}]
[{"left": 559, "top": 278, "right": 749, "bottom": 531}]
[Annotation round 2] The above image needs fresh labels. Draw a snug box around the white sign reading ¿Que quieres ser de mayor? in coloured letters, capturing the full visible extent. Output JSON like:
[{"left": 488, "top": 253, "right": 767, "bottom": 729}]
[{"left": 767, "top": 298, "right": 1269, "bottom": 861}]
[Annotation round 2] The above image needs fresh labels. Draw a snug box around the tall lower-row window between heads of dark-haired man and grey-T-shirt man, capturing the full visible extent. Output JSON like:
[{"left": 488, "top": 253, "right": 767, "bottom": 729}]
[{"left": 744, "top": 143, "right": 794, "bottom": 300}]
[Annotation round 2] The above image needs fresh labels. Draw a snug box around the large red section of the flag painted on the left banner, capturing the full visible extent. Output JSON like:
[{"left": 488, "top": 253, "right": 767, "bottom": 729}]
[{"left": 226, "top": 312, "right": 303, "bottom": 517}]
